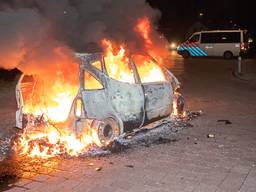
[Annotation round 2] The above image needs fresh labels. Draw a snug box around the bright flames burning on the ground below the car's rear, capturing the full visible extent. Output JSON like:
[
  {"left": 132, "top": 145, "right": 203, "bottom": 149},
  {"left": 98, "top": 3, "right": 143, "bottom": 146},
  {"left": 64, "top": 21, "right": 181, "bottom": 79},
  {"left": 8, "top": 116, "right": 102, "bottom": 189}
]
[{"left": 15, "top": 126, "right": 101, "bottom": 159}]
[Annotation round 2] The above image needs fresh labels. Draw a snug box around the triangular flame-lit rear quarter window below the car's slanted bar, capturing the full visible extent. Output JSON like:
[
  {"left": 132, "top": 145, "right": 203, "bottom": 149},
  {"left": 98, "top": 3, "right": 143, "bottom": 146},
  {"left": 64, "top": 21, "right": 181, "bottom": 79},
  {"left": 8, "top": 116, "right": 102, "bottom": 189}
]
[{"left": 84, "top": 71, "right": 103, "bottom": 90}]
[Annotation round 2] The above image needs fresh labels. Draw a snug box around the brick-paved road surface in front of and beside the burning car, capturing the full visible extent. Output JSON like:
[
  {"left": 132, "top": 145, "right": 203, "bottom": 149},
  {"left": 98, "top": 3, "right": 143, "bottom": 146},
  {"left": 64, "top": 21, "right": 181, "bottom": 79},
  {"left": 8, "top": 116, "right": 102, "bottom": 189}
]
[{"left": 1, "top": 53, "right": 256, "bottom": 192}]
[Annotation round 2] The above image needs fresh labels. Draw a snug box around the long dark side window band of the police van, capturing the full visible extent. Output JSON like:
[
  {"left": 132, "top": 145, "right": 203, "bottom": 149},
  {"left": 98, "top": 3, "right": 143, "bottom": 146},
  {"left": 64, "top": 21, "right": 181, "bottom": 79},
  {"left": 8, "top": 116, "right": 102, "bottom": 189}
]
[{"left": 201, "top": 32, "right": 241, "bottom": 43}]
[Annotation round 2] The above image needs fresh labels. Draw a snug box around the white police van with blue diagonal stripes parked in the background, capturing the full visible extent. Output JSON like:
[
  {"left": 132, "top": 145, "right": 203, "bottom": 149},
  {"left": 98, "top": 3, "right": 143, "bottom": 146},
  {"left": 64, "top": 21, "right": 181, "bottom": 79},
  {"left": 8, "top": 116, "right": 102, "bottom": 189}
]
[{"left": 177, "top": 30, "right": 248, "bottom": 59}]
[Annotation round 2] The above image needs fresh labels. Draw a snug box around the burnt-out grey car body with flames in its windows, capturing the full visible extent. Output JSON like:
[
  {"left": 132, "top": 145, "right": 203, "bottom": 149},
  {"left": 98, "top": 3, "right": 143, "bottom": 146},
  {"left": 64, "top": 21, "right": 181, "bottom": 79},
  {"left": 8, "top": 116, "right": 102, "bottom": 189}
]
[{"left": 16, "top": 53, "right": 184, "bottom": 145}]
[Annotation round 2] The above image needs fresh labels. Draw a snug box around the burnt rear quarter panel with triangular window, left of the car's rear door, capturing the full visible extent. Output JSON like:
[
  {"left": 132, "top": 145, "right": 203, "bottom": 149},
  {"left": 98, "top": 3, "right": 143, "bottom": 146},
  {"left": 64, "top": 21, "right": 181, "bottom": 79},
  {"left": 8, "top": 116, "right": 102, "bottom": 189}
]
[{"left": 69, "top": 58, "right": 111, "bottom": 134}]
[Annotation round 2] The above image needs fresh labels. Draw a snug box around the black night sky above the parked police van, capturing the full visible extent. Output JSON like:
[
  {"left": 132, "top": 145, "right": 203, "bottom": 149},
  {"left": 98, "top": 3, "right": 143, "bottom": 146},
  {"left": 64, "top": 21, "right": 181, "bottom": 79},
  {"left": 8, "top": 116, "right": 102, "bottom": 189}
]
[{"left": 147, "top": 0, "right": 256, "bottom": 40}]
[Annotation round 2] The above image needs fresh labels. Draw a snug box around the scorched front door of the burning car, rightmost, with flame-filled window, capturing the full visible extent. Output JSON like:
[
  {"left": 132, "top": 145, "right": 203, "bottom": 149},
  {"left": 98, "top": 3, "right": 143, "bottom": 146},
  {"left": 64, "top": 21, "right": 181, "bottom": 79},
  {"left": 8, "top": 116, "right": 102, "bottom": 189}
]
[{"left": 133, "top": 55, "right": 173, "bottom": 121}]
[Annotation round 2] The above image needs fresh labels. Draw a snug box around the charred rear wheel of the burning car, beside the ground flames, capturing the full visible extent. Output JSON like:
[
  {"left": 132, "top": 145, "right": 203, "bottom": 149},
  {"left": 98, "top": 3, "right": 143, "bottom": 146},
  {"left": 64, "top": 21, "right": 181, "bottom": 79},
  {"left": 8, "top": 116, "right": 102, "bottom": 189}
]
[{"left": 93, "top": 118, "right": 120, "bottom": 146}]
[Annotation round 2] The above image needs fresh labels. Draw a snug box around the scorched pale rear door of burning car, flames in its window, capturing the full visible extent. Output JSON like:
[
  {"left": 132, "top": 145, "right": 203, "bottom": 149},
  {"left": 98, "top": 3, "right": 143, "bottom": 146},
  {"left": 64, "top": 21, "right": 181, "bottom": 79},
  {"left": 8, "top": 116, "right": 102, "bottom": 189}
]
[{"left": 102, "top": 55, "right": 145, "bottom": 130}]
